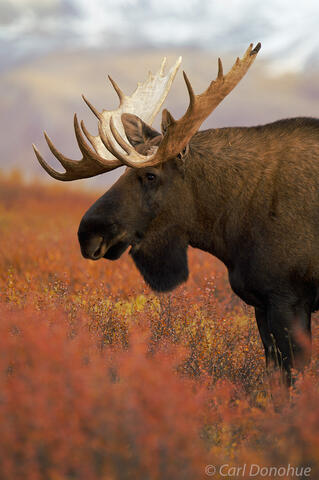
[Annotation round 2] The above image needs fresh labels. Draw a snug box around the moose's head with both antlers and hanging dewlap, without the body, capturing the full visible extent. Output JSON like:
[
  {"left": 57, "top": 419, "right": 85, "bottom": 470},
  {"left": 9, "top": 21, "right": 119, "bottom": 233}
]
[{"left": 34, "top": 44, "right": 260, "bottom": 291}]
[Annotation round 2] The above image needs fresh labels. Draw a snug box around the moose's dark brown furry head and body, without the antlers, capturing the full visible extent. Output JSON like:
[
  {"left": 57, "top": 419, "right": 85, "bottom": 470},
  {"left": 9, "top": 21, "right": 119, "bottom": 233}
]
[{"left": 79, "top": 118, "right": 319, "bottom": 382}]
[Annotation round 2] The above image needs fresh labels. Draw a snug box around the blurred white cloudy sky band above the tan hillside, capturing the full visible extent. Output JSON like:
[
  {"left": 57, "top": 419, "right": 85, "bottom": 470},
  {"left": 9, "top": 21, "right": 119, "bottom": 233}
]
[{"left": 0, "top": 0, "right": 319, "bottom": 74}]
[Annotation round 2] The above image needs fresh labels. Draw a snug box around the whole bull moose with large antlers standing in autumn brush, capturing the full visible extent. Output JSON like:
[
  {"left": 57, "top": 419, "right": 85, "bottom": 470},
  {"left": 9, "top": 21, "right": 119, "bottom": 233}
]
[{"left": 34, "top": 43, "right": 319, "bottom": 381}]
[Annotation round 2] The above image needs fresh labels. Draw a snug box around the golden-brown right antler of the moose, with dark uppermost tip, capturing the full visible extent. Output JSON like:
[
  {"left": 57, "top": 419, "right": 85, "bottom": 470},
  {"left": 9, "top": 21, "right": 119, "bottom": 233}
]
[{"left": 104, "top": 43, "right": 261, "bottom": 168}]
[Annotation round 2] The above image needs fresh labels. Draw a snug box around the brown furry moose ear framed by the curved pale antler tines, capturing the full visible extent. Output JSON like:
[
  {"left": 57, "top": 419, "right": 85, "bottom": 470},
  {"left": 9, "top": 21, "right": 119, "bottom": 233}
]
[{"left": 122, "top": 113, "right": 162, "bottom": 148}]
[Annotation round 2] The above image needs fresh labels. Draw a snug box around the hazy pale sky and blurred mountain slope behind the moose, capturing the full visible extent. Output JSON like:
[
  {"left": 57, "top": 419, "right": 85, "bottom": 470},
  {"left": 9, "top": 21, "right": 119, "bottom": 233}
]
[{"left": 0, "top": 0, "right": 319, "bottom": 187}]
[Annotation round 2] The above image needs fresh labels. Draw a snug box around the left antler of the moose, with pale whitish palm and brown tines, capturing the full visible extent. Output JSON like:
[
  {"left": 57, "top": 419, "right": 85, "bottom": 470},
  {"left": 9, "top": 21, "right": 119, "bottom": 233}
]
[{"left": 33, "top": 57, "right": 182, "bottom": 181}]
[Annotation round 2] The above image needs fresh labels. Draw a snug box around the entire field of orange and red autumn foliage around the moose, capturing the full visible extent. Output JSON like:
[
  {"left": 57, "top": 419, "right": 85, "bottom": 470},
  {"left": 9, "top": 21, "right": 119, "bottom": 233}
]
[{"left": 0, "top": 176, "right": 319, "bottom": 480}]
